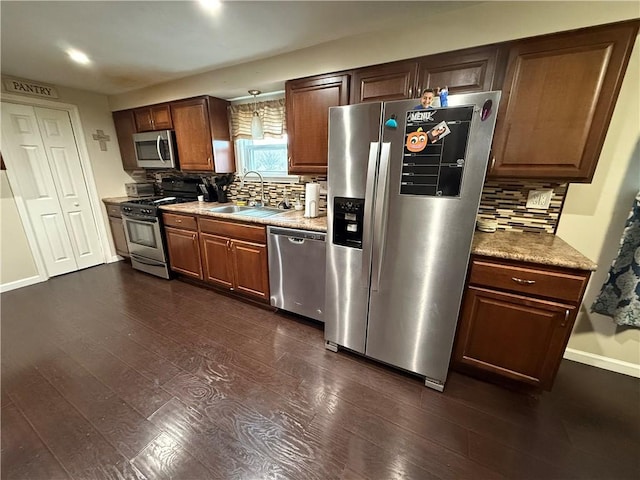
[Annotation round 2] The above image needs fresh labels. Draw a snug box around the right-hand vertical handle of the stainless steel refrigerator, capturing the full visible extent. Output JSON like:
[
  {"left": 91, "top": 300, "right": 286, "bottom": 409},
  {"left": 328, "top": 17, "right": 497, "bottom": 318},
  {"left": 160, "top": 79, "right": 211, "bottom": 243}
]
[{"left": 371, "top": 142, "right": 391, "bottom": 291}]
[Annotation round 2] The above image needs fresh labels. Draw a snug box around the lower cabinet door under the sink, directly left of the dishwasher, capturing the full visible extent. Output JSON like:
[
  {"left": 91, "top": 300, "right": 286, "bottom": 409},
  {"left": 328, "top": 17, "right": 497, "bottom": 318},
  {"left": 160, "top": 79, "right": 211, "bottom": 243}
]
[{"left": 231, "top": 240, "right": 269, "bottom": 300}]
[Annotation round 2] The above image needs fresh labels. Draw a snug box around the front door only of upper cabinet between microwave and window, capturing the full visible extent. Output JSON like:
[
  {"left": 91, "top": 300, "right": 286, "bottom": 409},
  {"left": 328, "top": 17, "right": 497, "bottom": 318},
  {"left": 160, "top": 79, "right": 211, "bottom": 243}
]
[{"left": 171, "top": 98, "right": 213, "bottom": 171}]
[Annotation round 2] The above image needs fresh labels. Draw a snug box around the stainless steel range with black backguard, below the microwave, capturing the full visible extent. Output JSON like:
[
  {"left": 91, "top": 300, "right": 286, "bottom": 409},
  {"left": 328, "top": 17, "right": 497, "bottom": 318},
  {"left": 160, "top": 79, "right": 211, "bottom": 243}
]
[{"left": 121, "top": 178, "right": 200, "bottom": 279}]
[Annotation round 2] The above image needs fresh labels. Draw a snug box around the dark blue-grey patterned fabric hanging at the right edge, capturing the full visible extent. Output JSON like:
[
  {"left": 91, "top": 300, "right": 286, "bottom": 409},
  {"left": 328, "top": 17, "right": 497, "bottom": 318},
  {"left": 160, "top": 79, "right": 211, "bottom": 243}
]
[{"left": 591, "top": 192, "right": 640, "bottom": 328}]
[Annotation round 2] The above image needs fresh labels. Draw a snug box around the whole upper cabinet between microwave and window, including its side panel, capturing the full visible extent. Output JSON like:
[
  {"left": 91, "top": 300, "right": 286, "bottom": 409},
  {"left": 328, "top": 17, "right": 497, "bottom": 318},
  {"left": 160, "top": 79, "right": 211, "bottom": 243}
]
[{"left": 171, "top": 96, "right": 235, "bottom": 173}]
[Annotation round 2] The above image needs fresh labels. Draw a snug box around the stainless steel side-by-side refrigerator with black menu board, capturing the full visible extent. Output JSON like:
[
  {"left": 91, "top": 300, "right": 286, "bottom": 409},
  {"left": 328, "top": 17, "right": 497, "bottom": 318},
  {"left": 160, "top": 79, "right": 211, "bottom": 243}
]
[{"left": 325, "top": 92, "right": 500, "bottom": 391}]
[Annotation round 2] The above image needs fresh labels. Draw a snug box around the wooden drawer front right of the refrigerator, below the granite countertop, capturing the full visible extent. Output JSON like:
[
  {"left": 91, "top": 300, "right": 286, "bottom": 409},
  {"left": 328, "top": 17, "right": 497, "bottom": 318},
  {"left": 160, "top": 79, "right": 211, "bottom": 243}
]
[{"left": 469, "top": 259, "right": 589, "bottom": 303}]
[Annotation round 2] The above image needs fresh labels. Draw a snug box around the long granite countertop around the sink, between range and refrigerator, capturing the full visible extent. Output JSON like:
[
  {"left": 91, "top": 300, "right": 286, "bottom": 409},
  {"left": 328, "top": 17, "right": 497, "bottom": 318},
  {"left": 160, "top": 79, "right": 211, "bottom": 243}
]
[{"left": 160, "top": 202, "right": 327, "bottom": 232}]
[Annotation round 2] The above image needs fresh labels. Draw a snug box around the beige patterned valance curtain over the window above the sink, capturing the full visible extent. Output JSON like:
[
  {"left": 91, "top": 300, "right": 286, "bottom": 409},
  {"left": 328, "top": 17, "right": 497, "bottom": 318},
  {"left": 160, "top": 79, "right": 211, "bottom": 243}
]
[{"left": 229, "top": 98, "right": 287, "bottom": 140}]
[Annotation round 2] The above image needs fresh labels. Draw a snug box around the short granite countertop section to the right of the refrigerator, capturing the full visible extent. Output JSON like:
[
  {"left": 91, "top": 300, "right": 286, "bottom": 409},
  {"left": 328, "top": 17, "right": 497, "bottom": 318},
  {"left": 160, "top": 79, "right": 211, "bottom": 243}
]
[{"left": 471, "top": 230, "right": 598, "bottom": 271}]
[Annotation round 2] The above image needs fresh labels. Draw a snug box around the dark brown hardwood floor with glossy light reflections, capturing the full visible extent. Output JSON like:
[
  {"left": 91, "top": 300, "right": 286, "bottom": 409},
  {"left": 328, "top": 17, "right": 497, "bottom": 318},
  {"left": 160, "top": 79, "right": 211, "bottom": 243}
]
[{"left": 1, "top": 263, "right": 640, "bottom": 480}]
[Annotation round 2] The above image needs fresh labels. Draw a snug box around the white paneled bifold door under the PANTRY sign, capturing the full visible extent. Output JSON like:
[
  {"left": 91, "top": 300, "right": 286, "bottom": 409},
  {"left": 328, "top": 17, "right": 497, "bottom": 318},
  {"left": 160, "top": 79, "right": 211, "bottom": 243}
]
[{"left": 2, "top": 102, "right": 103, "bottom": 276}]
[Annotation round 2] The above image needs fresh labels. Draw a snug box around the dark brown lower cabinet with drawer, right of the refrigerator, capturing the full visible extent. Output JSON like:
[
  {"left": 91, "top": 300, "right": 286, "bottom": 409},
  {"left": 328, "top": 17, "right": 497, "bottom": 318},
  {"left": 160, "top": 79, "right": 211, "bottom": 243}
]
[{"left": 453, "top": 257, "right": 590, "bottom": 390}]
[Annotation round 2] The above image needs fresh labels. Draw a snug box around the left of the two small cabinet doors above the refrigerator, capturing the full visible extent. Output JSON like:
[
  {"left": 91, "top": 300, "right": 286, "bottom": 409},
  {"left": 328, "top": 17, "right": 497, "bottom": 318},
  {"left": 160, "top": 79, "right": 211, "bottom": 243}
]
[{"left": 351, "top": 62, "right": 418, "bottom": 103}]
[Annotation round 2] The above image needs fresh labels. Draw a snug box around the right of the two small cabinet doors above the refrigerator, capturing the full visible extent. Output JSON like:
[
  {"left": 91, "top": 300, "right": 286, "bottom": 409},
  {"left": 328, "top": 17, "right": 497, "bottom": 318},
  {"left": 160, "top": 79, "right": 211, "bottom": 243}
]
[{"left": 416, "top": 46, "right": 504, "bottom": 95}]
